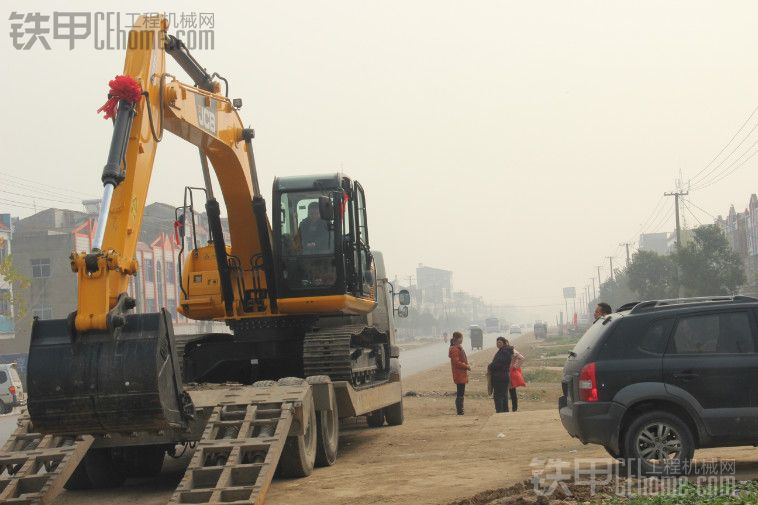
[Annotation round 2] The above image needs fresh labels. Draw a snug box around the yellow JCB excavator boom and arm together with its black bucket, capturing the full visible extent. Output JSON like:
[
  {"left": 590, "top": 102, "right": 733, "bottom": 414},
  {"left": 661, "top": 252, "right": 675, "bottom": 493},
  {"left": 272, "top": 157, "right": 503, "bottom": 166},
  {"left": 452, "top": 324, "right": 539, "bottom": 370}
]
[{"left": 28, "top": 16, "right": 276, "bottom": 433}]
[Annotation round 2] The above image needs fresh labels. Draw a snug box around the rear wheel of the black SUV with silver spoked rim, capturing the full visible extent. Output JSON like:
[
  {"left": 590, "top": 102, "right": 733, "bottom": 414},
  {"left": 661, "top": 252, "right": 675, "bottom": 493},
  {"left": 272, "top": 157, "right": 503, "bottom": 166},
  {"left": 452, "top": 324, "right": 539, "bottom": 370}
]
[{"left": 624, "top": 410, "right": 695, "bottom": 475}]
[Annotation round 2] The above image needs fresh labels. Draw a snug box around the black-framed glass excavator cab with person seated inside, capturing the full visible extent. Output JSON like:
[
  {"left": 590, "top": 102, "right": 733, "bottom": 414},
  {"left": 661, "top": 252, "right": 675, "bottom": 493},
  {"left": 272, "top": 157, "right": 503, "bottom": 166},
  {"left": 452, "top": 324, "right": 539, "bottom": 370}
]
[{"left": 273, "top": 173, "right": 376, "bottom": 314}]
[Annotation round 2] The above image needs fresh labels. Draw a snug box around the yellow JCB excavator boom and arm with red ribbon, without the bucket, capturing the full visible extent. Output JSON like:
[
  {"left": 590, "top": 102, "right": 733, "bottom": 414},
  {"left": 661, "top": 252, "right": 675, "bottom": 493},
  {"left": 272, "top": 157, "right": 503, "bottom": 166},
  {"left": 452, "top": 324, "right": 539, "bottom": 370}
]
[{"left": 71, "top": 17, "right": 275, "bottom": 332}]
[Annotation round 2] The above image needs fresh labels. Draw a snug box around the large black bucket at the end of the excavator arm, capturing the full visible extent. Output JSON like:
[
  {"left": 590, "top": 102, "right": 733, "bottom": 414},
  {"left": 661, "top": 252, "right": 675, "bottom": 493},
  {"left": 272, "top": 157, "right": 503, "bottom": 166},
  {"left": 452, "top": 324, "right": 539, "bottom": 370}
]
[{"left": 28, "top": 309, "right": 192, "bottom": 434}]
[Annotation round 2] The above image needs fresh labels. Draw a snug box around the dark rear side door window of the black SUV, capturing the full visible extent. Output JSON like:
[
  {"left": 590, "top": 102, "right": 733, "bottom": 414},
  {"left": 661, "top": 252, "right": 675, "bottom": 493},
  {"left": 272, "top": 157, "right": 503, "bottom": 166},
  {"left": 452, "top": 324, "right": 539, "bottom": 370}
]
[{"left": 669, "top": 312, "right": 755, "bottom": 354}]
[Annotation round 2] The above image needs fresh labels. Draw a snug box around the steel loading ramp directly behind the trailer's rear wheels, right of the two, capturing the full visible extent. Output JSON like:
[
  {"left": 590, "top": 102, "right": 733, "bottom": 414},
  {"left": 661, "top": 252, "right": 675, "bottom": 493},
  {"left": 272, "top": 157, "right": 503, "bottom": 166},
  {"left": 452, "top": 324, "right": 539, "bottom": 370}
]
[{"left": 169, "top": 386, "right": 306, "bottom": 505}]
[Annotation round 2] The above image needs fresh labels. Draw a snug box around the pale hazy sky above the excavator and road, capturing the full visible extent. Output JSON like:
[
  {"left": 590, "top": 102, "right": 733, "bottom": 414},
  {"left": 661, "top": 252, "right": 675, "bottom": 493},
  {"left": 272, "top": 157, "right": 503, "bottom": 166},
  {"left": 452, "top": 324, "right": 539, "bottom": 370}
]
[{"left": 0, "top": 0, "right": 758, "bottom": 320}]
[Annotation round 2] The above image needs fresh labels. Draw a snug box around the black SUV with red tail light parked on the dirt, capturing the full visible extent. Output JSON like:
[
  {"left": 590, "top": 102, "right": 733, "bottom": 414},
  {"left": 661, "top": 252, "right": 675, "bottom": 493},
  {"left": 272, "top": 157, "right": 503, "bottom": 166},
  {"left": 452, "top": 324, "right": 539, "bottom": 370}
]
[{"left": 558, "top": 296, "right": 758, "bottom": 473}]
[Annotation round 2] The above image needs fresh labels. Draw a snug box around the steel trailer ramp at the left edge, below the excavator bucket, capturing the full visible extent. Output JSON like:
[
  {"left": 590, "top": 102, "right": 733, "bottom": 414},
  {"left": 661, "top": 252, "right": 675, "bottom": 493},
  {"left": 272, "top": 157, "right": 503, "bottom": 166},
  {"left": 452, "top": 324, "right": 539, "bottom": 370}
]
[{"left": 0, "top": 416, "right": 93, "bottom": 505}]
